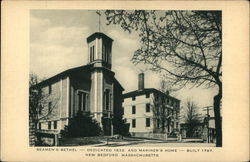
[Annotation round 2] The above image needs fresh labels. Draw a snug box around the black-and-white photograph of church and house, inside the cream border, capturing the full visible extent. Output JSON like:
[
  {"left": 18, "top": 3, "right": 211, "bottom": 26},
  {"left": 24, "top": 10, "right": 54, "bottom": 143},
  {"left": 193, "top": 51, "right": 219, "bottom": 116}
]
[{"left": 29, "top": 9, "right": 223, "bottom": 147}]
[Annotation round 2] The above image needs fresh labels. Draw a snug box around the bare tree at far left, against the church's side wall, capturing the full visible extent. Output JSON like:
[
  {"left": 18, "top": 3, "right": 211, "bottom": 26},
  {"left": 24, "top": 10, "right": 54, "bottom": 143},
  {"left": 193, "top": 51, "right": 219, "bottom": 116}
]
[{"left": 29, "top": 74, "right": 59, "bottom": 131}]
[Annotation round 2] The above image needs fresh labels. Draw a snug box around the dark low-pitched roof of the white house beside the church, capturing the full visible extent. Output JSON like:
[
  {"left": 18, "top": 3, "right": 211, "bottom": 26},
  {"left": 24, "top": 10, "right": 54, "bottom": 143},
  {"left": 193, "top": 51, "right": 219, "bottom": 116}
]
[{"left": 123, "top": 88, "right": 180, "bottom": 101}]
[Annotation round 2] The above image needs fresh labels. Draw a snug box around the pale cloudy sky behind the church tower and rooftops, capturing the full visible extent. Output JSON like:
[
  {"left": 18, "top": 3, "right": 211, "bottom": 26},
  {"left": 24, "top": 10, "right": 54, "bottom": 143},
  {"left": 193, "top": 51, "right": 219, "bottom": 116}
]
[{"left": 30, "top": 10, "right": 216, "bottom": 113}]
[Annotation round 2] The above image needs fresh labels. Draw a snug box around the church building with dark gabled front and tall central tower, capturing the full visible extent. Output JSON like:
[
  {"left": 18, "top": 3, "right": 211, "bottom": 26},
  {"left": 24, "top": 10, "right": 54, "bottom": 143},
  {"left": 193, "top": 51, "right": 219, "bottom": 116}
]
[{"left": 32, "top": 32, "right": 124, "bottom": 135}]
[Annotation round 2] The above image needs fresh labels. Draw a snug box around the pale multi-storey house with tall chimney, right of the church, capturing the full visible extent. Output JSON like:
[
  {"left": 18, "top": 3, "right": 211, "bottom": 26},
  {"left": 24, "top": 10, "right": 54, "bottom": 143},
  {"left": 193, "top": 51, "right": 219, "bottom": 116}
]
[{"left": 122, "top": 73, "right": 180, "bottom": 136}]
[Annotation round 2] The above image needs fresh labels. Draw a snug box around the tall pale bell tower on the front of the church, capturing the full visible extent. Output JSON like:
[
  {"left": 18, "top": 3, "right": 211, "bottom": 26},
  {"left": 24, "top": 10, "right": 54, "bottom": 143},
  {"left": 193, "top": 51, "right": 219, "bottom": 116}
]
[{"left": 87, "top": 32, "right": 114, "bottom": 132}]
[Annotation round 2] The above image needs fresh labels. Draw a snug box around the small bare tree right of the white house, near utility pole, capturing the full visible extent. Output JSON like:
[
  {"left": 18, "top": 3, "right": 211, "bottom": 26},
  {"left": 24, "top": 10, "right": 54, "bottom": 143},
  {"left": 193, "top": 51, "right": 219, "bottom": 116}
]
[{"left": 184, "top": 99, "right": 202, "bottom": 137}]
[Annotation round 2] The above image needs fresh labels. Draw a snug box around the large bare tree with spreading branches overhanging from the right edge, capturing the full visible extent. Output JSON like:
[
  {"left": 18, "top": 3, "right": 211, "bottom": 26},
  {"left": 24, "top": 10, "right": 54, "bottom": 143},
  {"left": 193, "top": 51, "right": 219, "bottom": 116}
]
[{"left": 105, "top": 10, "right": 222, "bottom": 147}]
